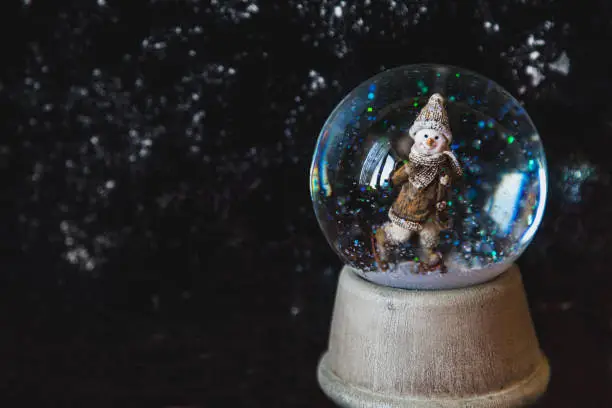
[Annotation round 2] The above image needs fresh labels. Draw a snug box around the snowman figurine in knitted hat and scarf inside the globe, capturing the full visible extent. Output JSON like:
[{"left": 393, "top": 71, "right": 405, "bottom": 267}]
[{"left": 372, "top": 94, "right": 463, "bottom": 273}]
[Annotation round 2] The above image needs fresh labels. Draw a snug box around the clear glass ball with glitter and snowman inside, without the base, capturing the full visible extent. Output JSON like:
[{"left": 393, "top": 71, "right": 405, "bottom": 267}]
[{"left": 310, "top": 65, "right": 547, "bottom": 289}]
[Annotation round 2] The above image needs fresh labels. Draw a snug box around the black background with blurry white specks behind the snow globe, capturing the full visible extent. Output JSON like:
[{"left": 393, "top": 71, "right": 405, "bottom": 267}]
[{"left": 0, "top": 0, "right": 612, "bottom": 408}]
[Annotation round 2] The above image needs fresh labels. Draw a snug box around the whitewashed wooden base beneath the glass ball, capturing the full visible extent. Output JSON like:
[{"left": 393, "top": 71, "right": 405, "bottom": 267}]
[{"left": 318, "top": 266, "right": 550, "bottom": 408}]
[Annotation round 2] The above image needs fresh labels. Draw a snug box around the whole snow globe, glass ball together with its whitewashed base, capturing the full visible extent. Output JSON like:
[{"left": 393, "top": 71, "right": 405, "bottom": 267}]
[{"left": 310, "top": 64, "right": 549, "bottom": 407}]
